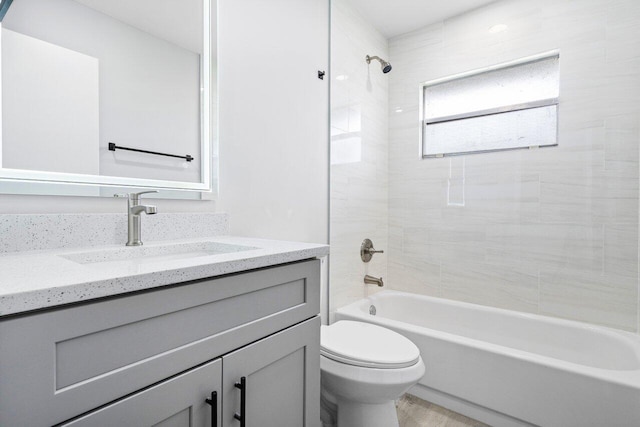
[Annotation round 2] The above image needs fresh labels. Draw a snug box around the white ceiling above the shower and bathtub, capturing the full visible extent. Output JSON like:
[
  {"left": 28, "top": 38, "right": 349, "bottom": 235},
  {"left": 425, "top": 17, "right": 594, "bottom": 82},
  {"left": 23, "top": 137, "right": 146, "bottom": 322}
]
[{"left": 347, "top": 0, "right": 495, "bottom": 38}]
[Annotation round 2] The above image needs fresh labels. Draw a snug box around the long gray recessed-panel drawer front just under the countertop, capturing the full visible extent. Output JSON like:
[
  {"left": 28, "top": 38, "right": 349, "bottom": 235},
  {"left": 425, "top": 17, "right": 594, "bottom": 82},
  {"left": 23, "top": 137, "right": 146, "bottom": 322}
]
[{"left": 0, "top": 260, "right": 320, "bottom": 426}]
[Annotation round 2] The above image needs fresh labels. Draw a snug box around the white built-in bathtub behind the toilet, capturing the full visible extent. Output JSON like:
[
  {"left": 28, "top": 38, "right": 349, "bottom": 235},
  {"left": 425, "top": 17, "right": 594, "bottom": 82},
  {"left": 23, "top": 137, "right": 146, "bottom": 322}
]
[{"left": 335, "top": 291, "right": 640, "bottom": 427}]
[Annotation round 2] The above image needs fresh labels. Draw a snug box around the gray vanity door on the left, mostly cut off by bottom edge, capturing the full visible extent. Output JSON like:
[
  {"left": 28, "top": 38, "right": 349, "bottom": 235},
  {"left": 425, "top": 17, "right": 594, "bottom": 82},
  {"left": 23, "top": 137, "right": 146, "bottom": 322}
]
[{"left": 61, "top": 359, "right": 222, "bottom": 427}]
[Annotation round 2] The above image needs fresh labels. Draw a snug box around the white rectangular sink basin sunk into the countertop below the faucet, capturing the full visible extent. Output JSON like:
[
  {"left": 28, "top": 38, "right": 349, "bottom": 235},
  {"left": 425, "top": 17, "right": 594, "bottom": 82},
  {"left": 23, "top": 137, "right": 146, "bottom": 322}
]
[{"left": 59, "top": 242, "right": 259, "bottom": 264}]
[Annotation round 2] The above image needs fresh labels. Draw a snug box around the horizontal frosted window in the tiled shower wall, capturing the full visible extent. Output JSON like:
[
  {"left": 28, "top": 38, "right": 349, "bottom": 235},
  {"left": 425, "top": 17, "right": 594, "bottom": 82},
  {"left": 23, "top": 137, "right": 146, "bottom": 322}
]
[{"left": 422, "top": 53, "right": 559, "bottom": 157}]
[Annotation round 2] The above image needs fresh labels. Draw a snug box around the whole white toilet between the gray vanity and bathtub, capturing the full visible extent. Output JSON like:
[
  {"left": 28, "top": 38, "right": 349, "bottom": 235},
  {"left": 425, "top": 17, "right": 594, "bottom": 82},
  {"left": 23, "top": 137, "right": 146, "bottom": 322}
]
[{"left": 320, "top": 320, "right": 425, "bottom": 427}]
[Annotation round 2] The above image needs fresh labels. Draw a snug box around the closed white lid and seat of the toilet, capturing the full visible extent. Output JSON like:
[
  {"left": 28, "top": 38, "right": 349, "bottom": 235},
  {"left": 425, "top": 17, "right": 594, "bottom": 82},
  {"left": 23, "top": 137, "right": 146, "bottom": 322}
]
[{"left": 320, "top": 320, "right": 420, "bottom": 369}]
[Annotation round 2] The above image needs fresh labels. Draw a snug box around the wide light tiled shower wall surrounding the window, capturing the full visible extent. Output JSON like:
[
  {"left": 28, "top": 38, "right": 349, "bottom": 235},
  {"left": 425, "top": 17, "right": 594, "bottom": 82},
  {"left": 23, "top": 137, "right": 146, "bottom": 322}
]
[{"left": 384, "top": 0, "right": 640, "bottom": 331}]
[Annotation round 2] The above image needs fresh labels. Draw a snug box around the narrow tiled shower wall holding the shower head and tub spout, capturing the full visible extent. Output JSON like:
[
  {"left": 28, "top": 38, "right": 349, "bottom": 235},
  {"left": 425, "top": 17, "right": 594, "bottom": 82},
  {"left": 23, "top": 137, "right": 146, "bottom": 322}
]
[{"left": 329, "top": 0, "right": 389, "bottom": 310}]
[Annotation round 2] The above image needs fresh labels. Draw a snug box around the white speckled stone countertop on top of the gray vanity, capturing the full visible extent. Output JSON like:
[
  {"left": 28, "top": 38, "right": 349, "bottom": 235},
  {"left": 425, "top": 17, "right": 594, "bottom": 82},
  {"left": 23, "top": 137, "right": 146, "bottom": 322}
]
[{"left": 0, "top": 236, "right": 329, "bottom": 316}]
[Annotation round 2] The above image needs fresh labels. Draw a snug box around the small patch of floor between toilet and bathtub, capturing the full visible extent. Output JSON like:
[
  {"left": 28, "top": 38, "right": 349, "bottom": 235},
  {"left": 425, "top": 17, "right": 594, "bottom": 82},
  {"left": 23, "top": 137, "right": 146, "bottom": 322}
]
[{"left": 397, "top": 394, "right": 490, "bottom": 427}]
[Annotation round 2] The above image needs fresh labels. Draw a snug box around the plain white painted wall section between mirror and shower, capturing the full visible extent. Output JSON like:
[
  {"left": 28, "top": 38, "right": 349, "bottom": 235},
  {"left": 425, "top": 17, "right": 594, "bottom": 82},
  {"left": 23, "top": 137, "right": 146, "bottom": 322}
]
[{"left": 218, "top": 0, "right": 329, "bottom": 243}]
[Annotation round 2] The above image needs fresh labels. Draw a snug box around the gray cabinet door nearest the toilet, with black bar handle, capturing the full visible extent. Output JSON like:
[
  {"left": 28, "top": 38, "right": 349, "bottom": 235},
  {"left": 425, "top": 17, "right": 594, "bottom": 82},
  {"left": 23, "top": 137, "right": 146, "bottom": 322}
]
[{"left": 222, "top": 317, "right": 320, "bottom": 427}]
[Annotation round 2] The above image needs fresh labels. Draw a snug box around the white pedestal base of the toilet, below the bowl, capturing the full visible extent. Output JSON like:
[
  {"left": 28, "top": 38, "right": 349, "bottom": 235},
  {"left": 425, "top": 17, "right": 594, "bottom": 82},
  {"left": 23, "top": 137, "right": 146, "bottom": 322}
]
[{"left": 321, "top": 393, "right": 399, "bottom": 427}]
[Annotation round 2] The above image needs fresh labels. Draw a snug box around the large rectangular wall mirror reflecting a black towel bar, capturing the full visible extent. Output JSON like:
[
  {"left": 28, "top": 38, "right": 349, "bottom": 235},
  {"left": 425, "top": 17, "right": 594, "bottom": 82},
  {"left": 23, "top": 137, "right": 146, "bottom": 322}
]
[{"left": 0, "top": 0, "right": 216, "bottom": 196}]
